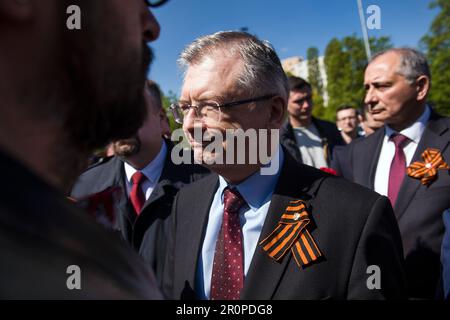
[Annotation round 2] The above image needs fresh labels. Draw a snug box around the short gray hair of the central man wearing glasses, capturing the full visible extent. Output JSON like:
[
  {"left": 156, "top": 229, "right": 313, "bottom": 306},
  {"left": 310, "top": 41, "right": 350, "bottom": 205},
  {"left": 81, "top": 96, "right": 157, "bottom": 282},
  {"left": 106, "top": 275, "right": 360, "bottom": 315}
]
[{"left": 178, "top": 31, "right": 289, "bottom": 101}]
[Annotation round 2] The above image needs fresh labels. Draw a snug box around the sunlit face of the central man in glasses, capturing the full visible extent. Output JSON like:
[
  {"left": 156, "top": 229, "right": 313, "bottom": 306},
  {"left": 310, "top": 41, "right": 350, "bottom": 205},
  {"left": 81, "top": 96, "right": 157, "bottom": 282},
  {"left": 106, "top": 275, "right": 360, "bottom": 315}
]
[{"left": 180, "top": 51, "right": 270, "bottom": 167}]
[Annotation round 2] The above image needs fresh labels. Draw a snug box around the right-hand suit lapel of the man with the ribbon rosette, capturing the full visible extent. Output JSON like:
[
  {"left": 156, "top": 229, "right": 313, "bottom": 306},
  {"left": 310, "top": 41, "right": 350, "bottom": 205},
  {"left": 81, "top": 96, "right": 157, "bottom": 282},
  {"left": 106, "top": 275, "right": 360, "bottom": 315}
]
[{"left": 394, "top": 114, "right": 450, "bottom": 220}]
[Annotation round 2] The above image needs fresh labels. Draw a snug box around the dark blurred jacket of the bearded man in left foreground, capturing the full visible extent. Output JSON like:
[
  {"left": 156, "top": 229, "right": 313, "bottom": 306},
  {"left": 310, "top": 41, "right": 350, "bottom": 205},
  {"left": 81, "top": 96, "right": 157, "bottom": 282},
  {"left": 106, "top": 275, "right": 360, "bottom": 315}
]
[{"left": 0, "top": 152, "right": 162, "bottom": 299}]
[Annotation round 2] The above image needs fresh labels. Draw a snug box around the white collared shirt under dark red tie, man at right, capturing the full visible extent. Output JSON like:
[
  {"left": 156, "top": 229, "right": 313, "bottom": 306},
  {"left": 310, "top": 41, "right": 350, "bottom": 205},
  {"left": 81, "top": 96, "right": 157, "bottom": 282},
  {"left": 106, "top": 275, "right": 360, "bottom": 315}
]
[{"left": 374, "top": 106, "right": 431, "bottom": 196}]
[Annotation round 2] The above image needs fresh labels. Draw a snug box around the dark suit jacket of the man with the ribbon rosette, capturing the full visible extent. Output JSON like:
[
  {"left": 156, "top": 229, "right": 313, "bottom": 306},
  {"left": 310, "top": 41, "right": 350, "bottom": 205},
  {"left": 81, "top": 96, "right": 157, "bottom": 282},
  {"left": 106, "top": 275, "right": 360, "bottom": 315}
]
[{"left": 334, "top": 113, "right": 450, "bottom": 298}]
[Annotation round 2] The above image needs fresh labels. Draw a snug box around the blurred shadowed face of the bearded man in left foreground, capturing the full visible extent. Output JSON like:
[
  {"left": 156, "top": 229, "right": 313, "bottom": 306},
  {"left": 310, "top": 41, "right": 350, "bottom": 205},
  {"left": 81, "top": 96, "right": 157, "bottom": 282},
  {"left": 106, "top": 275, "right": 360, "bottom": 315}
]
[{"left": 63, "top": 0, "right": 159, "bottom": 150}]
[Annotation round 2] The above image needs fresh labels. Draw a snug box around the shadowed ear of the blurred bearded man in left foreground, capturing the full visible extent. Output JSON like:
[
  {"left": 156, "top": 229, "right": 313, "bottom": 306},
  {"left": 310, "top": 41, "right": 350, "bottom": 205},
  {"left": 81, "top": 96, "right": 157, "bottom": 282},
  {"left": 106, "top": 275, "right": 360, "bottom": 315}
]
[{"left": 0, "top": 0, "right": 36, "bottom": 24}]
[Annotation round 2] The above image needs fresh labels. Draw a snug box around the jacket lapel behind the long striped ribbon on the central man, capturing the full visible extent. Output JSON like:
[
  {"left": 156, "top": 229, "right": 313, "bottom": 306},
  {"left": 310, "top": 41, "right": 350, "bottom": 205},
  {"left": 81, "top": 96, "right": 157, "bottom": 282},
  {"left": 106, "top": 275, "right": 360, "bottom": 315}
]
[{"left": 241, "top": 153, "right": 323, "bottom": 300}]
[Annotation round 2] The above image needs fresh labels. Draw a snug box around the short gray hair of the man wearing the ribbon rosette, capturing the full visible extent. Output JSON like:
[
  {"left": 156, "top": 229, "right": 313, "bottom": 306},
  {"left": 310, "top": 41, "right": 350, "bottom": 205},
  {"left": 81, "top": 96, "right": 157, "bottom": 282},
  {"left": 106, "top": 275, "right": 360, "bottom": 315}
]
[{"left": 370, "top": 48, "right": 431, "bottom": 84}]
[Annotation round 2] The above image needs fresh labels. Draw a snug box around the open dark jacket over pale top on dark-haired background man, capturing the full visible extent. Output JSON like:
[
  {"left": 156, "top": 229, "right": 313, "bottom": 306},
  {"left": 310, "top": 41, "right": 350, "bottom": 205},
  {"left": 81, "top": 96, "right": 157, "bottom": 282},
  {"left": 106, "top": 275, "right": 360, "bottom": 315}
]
[{"left": 280, "top": 117, "right": 345, "bottom": 168}]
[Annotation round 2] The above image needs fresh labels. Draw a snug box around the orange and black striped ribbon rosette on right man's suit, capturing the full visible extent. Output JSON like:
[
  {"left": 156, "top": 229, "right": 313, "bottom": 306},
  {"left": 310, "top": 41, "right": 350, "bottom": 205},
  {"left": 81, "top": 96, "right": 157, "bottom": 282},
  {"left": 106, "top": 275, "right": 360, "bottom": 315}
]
[{"left": 407, "top": 148, "right": 450, "bottom": 185}]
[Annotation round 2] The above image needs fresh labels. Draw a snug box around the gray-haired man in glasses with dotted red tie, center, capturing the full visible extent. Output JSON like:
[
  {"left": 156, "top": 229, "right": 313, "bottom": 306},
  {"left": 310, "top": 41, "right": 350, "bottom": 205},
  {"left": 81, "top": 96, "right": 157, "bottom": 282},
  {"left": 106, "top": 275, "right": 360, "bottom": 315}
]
[{"left": 164, "top": 32, "right": 404, "bottom": 300}]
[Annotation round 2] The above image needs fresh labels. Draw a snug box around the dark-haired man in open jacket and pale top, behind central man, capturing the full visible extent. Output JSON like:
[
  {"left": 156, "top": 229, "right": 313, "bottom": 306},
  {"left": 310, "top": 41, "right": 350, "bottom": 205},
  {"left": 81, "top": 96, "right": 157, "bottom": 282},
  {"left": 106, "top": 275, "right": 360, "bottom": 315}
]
[{"left": 280, "top": 76, "right": 345, "bottom": 168}]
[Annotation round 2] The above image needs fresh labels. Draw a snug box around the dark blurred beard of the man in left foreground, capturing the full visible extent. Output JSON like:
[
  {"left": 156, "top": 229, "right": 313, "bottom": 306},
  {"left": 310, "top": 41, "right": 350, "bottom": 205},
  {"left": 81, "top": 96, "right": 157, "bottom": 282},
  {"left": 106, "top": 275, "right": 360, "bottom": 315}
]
[{"left": 65, "top": 44, "right": 153, "bottom": 154}]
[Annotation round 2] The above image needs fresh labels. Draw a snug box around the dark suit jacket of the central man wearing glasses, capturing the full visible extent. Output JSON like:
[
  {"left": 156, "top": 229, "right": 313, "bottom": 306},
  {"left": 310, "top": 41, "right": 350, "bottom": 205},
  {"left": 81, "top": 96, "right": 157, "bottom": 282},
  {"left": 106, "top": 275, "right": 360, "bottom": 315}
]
[{"left": 164, "top": 150, "right": 406, "bottom": 300}]
